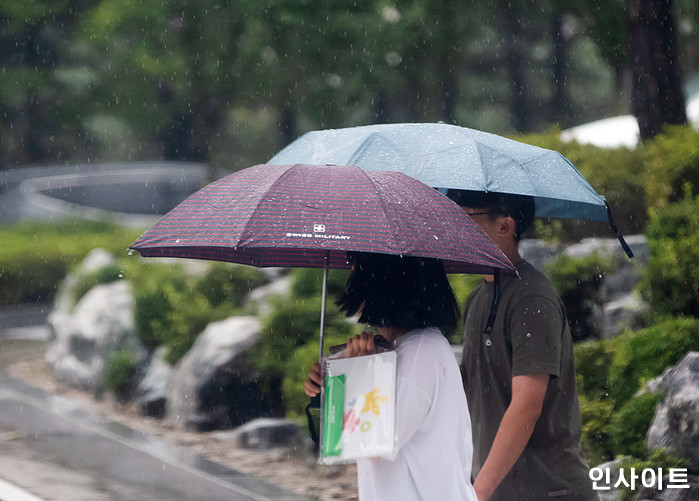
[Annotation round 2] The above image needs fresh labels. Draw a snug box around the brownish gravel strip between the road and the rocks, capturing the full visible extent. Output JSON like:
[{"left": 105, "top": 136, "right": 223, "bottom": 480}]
[{"left": 0, "top": 340, "right": 357, "bottom": 501}]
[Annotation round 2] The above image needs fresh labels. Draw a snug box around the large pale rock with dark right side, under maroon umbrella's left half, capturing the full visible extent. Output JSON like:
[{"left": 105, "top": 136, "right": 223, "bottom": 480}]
[{"left": 167, "top": 317, "right": 268, "bottom": 431}]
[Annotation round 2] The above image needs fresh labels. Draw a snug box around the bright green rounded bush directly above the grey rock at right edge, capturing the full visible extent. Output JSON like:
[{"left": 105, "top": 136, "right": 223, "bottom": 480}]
[{"left": 609, "top": 317, "right": 699, "bottom": 408}]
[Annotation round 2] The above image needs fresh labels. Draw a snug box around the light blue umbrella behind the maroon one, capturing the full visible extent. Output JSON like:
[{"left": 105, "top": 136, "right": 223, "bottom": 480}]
[{"left": 267, "top": 123, "right": 633, "bottom": 256}]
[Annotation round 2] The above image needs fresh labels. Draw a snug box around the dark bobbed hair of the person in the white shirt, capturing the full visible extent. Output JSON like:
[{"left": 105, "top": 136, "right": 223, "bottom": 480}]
[{"left": 337, "top": 253, "right": 459, "bottom": 330}]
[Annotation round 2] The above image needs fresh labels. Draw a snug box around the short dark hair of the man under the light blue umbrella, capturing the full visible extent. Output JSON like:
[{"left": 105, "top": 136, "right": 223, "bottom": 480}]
[{"left": 447, "top": 190, "right": 535, "bottom": 242}]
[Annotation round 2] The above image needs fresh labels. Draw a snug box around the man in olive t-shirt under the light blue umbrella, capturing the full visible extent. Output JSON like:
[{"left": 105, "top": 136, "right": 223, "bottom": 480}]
[{"left": 449, "top": 192, "right": 598, "bottom": 501}]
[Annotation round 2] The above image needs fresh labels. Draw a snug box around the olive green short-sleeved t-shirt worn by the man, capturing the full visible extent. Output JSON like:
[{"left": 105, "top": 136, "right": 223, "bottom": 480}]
[{"left": 462, "top": 261, "right": 597, "bottom": 501}]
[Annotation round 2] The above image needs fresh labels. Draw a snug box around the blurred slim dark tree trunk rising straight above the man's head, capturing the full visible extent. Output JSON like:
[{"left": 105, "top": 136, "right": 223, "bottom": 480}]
[{"left": 503, "top": 0, "right": 530, "bottom": 133}]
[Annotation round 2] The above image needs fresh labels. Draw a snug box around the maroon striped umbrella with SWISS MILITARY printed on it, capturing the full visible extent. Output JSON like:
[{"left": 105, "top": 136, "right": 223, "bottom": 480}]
[{"left": 131, "top": 165, "right": 515, "bottom": 355}]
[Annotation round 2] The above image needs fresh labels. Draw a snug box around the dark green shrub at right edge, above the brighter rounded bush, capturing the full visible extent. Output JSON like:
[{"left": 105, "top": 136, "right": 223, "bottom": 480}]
[{"left": 641, "top": 189, "right": 699, "bottom": 317}]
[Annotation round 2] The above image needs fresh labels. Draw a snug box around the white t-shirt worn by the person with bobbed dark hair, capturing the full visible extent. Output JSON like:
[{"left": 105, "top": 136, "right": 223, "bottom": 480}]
[{"left": 357, "top": 328, "right": 477, "bottom": 501}]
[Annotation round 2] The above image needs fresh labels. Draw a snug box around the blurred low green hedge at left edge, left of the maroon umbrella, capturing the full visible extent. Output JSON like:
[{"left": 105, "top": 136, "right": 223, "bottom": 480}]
[{"left": 0, "top": 221, "right": 140, "bottom": 306}]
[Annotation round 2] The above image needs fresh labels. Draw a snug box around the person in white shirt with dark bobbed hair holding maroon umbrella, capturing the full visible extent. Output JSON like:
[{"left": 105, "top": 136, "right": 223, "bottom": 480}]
[{"left": 305, "top": 253, "right": 477, "bottom": 501}]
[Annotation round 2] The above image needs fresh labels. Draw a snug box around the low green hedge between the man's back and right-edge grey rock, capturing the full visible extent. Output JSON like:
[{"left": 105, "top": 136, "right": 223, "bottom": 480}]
[{"left": 575, "top": 317, "right": 699, "bottom": 464}]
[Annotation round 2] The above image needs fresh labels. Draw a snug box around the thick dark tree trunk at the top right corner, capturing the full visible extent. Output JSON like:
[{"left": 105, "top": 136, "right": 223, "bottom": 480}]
[{"left": 626, "top": 0, "right": 687, "bottom": 140}]
